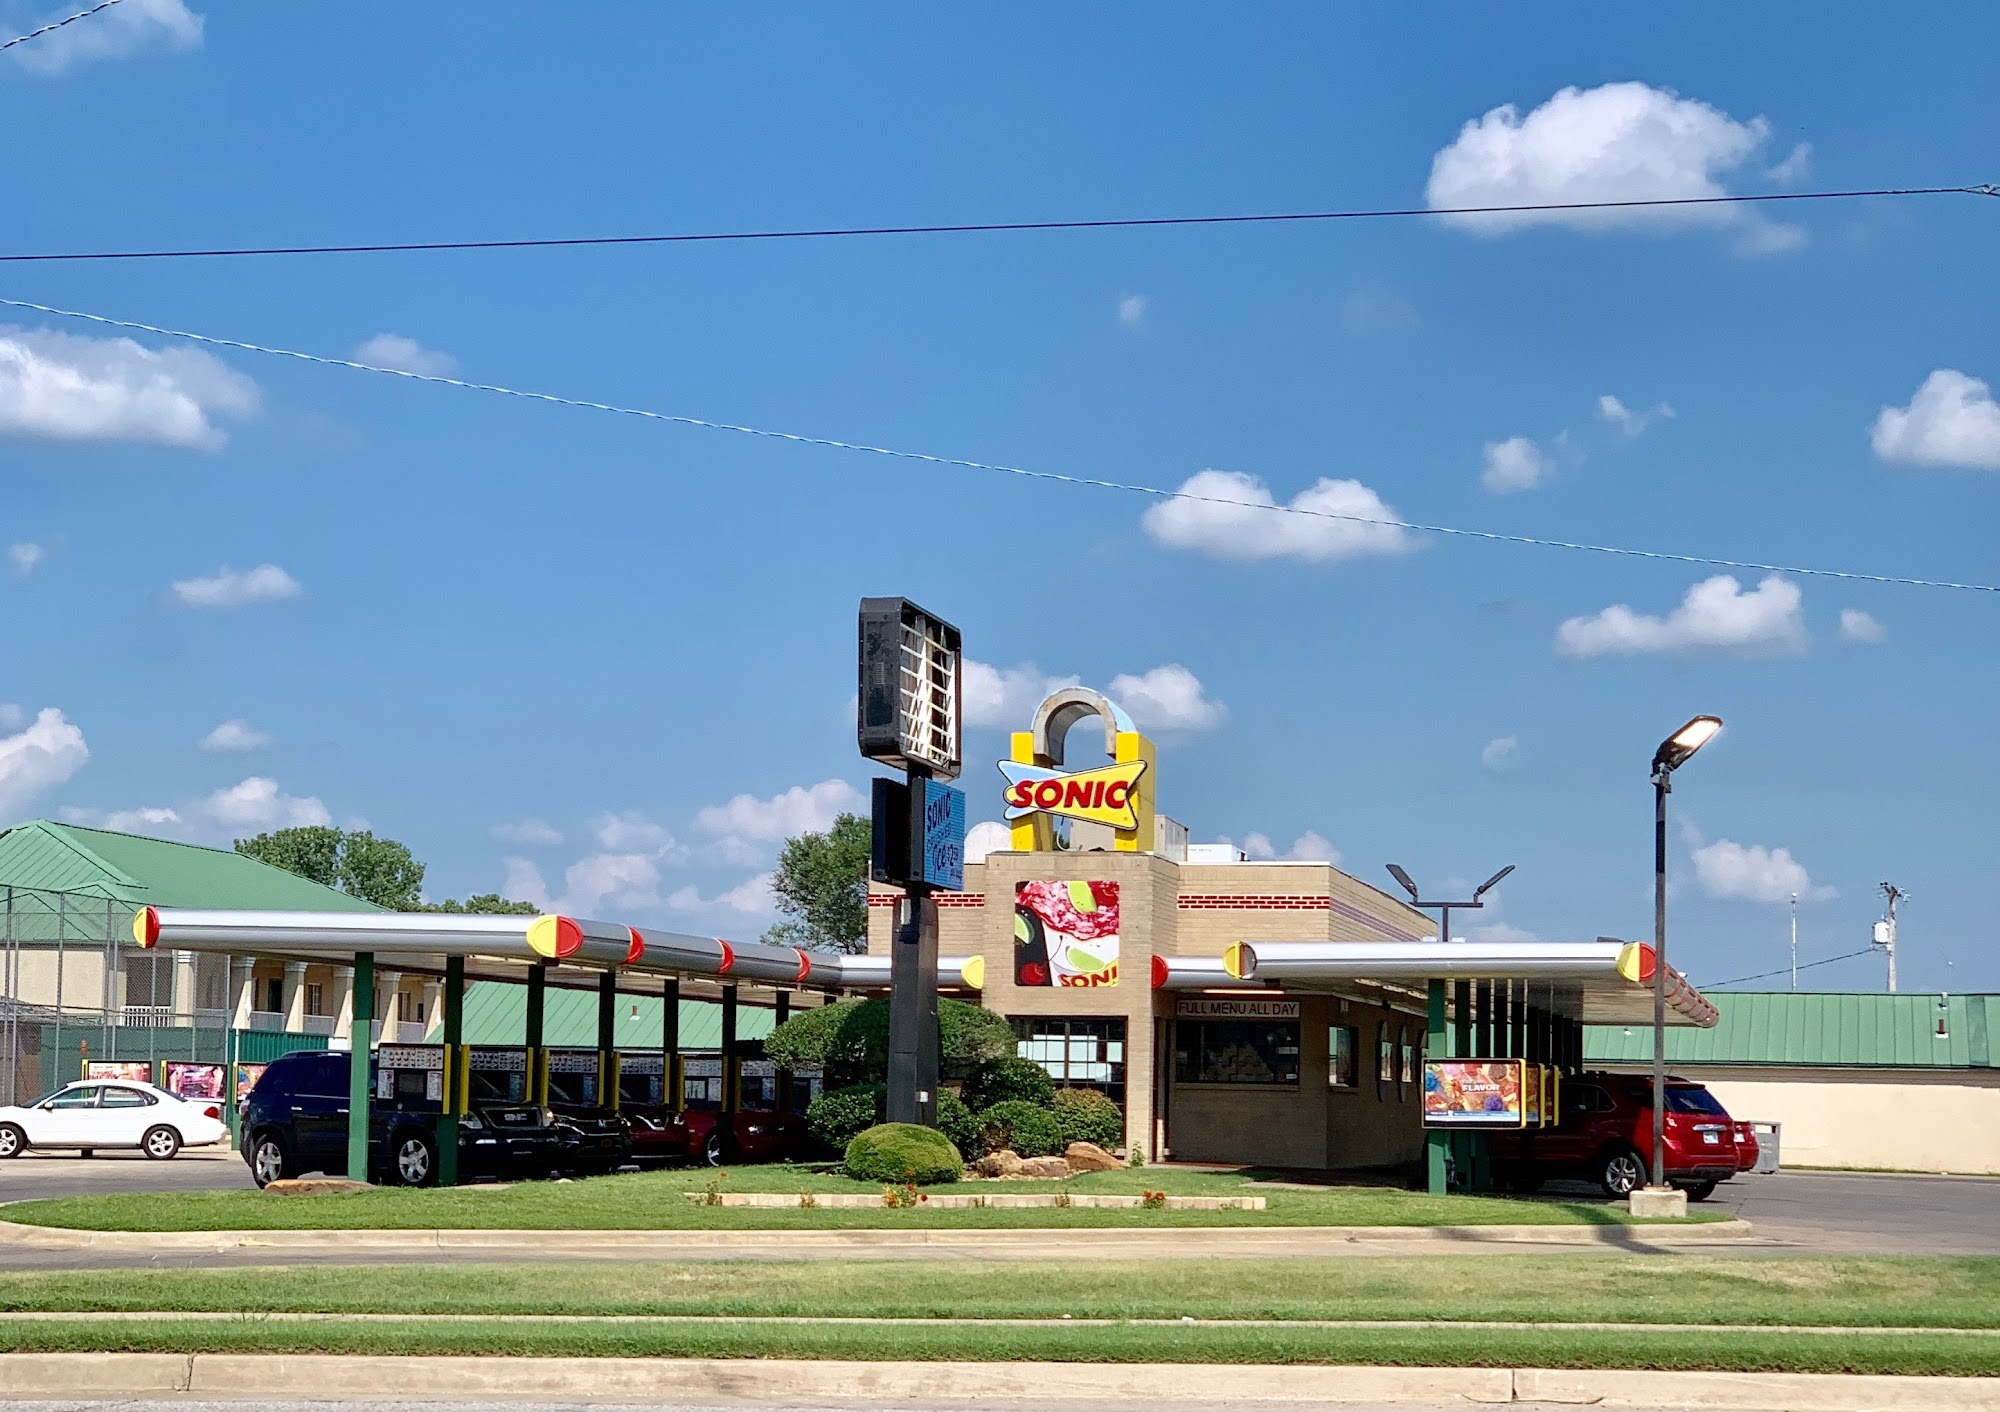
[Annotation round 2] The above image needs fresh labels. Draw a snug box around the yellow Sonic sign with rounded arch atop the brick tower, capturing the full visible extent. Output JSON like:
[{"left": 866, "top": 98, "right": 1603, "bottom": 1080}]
[{"left": 1000, "top": 686, "right": 1154, "bottom": 852}]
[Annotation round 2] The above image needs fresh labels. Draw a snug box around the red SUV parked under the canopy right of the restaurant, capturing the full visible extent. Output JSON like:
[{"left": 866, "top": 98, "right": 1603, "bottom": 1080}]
[{"left": 1492, "top": 1074, "right": 1756, "bottom": 1202}]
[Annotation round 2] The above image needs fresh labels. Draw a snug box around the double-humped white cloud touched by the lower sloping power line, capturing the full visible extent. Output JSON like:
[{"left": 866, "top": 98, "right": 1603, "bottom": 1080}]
[{"left": 1142, "top": 470, "right": 1416, "bottom": 564}]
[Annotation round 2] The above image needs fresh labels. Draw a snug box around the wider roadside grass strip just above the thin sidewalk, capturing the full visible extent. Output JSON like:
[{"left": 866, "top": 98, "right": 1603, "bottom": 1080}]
[{"left": 0, "top": 1256, "right": 2000, "bottom": 1320}]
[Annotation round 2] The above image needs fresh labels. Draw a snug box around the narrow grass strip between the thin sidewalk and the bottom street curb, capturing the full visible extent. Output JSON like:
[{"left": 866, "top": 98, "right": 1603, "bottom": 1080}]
[{"left": 0, "top": 1316, "right": 2000, "bottom": 1376}]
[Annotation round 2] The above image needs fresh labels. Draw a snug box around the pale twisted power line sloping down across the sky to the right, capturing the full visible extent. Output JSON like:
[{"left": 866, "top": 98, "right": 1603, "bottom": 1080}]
[{"left": 0, "top": 298, "right": 2000, "bottom": 594}]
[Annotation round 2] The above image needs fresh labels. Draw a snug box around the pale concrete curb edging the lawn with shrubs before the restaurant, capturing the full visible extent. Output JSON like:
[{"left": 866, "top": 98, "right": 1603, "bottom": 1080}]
[{"left": 0, "top": 1220, "right": 1756, "bottom": 1260}]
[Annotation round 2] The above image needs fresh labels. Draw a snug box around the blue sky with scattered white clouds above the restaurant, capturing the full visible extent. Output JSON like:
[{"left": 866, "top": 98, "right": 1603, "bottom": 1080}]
[{"left": 0, "top": 0, "right": 2000, "bottom": 990}]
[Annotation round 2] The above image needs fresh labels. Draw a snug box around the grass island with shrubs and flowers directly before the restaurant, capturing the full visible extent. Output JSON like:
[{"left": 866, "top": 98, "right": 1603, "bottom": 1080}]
[{"left": 0, "top": 1166, "right": 1724, "bottom": 1230}]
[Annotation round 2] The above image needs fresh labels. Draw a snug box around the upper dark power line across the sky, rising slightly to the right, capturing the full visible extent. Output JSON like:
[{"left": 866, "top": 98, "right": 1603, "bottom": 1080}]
[{"left": 0, "top": 183, "right": 2000, "bottom": 264}]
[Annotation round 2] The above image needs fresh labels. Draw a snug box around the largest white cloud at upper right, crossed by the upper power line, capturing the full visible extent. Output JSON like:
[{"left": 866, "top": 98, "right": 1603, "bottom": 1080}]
[{"left": 1426, "top": 82, "right": 1802, "bottom": 252}]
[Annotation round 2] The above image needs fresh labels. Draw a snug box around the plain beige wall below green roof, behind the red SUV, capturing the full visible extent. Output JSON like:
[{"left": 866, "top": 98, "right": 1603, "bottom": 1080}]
[{"left": 1624, "top": 1066, "right": 2000, "bottom": 1176}]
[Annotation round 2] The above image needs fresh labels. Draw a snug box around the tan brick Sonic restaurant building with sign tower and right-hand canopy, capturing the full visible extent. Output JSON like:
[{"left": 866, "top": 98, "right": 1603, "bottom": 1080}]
[{"left": 868, "top": 688, "right": 1714, "bottom": 1182}]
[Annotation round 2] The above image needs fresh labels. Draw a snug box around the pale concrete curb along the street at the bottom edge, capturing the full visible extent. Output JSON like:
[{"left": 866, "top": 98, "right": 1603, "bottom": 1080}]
[{"left": 0, "top": 1354, "right": 2000, "bottom": 1412}]
